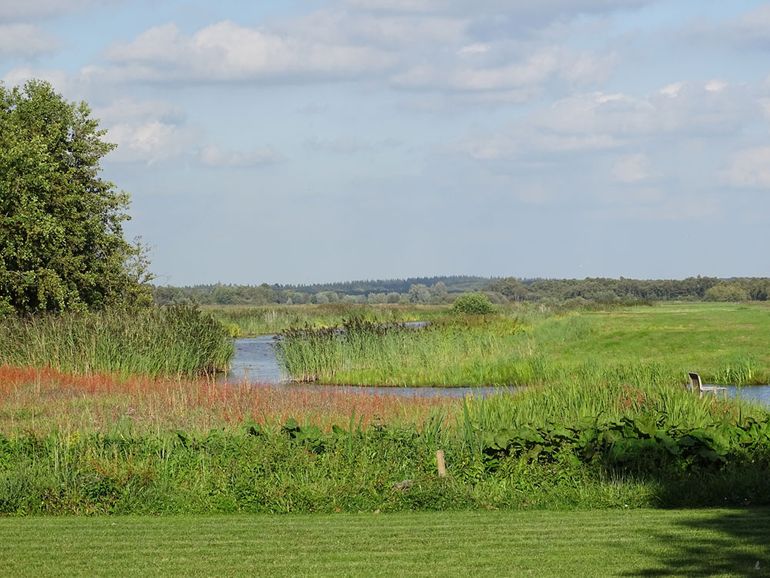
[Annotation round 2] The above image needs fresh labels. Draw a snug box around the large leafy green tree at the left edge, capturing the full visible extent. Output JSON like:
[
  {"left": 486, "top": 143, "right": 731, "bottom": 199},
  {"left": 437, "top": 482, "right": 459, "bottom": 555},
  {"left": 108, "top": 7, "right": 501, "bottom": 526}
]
[{"left": 0, "top": 81, "right": 149, "bottom": 313}]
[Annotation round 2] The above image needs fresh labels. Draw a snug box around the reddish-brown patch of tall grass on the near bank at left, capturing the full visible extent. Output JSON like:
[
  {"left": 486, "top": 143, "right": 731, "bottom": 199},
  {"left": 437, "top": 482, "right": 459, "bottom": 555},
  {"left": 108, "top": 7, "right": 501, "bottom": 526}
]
[{"left": 0, "top": 366, "right": 450, "bottom": 435}]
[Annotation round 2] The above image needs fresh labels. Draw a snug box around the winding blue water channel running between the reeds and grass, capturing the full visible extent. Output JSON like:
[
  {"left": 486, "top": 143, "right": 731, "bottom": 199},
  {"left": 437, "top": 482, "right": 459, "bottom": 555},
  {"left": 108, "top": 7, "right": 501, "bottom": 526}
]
[{"left": 222, "top": 332, "right": 770, "bottom": 405}]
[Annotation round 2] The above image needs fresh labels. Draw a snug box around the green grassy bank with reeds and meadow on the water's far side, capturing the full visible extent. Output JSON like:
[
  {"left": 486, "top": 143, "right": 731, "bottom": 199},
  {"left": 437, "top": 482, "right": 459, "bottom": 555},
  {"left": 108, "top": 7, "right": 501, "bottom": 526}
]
[{"left": 280, "top": 303, "right": 770, "bottom": 386}]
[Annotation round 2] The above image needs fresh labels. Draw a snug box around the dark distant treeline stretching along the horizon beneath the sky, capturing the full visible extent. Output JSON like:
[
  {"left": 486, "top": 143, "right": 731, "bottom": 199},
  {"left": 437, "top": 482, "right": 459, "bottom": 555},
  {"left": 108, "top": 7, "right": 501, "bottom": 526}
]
[{"left": 154, "top": 275, "right": 770, "bottom": 305}]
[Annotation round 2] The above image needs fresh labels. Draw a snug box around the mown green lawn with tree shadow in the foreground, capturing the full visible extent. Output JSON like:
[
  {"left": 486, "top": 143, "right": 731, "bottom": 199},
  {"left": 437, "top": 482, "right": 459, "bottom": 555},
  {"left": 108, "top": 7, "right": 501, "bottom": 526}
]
[{"left": 0, "top": 510, "right": 770, "bottom": 576}]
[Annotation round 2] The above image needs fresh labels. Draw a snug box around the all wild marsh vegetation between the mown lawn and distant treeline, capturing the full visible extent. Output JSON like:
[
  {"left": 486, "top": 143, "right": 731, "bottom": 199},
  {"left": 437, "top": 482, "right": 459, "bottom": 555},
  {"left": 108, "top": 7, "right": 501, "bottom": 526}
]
[{"left": 0, "top": 296, "right": 770, "bottom": 514}]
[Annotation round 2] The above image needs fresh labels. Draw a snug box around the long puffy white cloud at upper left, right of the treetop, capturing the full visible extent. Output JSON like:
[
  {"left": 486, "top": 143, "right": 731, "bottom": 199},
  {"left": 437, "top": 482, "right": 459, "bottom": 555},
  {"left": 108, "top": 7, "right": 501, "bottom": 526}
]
[{"left": 103, "top": 21, "right": 392, "bottom": 83}]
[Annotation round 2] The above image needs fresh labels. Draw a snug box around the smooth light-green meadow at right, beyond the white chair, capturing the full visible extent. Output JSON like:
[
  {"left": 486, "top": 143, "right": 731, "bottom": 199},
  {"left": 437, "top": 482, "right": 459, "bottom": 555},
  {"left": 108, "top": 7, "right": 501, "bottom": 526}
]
[{"left": 530, "top": 303, "right": 770, "bottom": 384}]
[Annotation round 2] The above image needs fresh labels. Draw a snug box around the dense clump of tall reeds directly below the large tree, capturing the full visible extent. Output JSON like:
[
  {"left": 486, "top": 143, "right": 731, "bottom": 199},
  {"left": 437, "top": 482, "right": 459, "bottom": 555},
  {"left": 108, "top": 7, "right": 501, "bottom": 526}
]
[{"left": 0, "top": 306, "right": 233, "bottom": 377}]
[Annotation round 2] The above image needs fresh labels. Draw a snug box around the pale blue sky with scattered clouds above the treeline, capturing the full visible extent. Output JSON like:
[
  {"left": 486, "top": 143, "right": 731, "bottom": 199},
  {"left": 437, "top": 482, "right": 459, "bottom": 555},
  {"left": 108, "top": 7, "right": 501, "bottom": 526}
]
[{"left": 0, "top": 0, "right": 770, "bottom": 285}]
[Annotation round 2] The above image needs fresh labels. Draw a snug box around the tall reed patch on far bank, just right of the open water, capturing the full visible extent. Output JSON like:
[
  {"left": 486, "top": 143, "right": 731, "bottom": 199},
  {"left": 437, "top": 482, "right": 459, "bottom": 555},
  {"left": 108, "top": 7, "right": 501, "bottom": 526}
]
[{"left": 277, "top": 317, "right": 520, "bottom": 386}]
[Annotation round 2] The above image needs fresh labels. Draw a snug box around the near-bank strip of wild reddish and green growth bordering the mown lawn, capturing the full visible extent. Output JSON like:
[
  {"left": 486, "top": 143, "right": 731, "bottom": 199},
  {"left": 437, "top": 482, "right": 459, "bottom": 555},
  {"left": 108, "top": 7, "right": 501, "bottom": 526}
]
[{"left": 0, "top": 367, "right": 770, "bottom": 514}]
